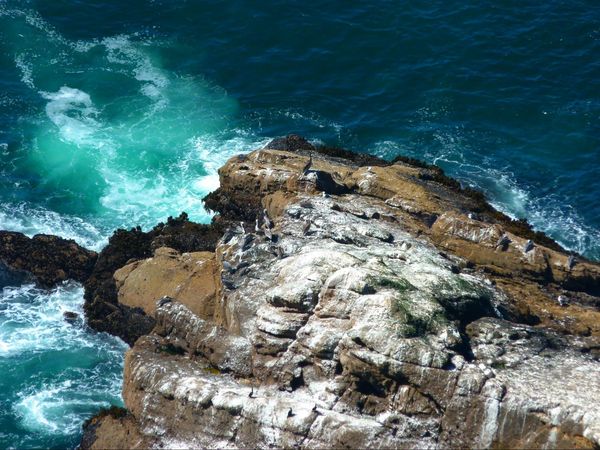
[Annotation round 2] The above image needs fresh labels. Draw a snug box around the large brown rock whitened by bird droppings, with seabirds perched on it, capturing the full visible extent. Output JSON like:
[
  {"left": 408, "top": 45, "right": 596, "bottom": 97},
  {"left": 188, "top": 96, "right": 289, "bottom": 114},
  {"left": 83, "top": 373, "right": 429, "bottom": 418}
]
[{"left": 82, "top": 137, "right": 600, "bottom": 448}]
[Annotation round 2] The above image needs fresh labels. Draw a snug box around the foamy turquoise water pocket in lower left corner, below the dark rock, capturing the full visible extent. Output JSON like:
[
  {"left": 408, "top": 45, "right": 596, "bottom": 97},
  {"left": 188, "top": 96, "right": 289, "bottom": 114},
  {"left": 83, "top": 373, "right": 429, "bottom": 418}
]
[{"left": 0, "top": 284, "right": 127, "bottom": 448}]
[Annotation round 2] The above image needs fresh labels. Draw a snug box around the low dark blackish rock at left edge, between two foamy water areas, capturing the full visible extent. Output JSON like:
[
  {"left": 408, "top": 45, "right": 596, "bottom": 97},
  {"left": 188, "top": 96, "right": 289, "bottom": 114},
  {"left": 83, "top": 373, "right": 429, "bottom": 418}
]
[{"left": 0, "top": 231, "right": 97, "bottom": 288}]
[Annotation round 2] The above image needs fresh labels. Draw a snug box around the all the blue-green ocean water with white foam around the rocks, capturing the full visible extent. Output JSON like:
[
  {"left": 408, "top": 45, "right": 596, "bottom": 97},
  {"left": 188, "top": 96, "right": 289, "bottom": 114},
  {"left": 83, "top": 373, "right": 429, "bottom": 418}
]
[{"left": 0, "top": 0, "right": 600, "bottom": 448}]
